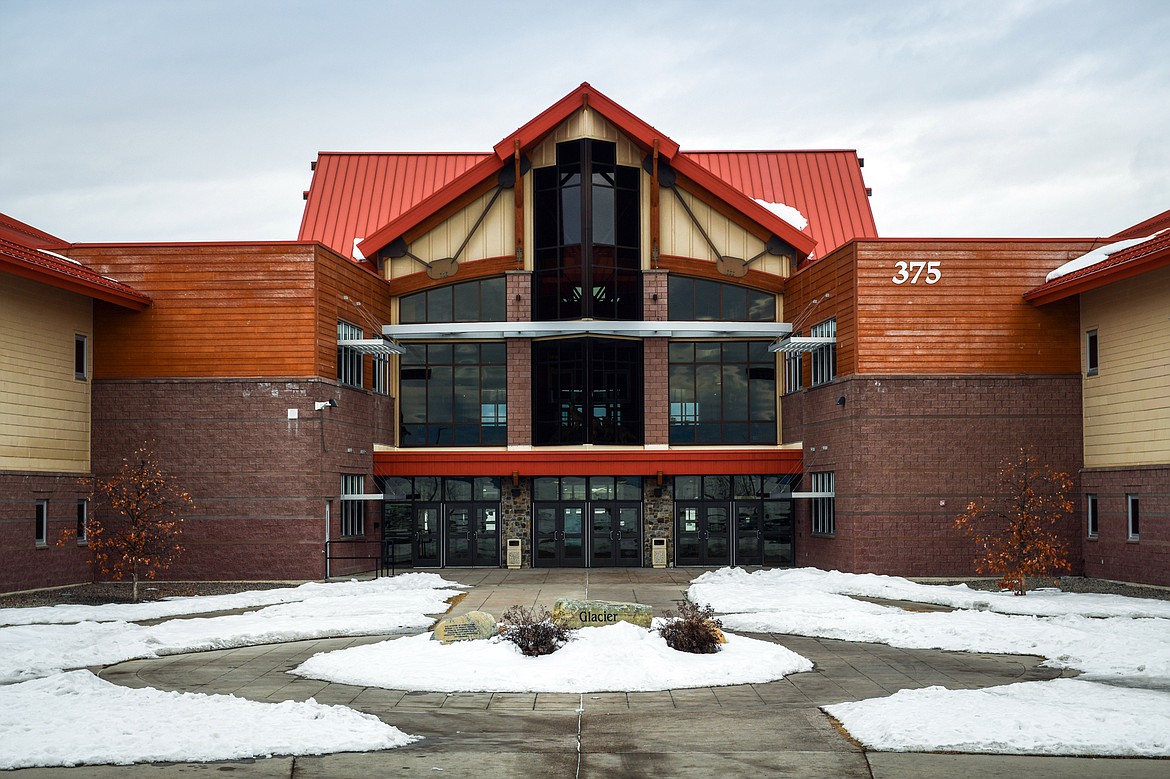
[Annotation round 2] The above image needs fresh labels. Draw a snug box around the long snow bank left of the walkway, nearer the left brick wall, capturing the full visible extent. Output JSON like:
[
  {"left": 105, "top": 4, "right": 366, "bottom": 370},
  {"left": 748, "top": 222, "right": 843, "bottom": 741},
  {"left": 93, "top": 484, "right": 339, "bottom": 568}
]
[{"left": 0, "top": 573, "right": 459, "bottom": 684}]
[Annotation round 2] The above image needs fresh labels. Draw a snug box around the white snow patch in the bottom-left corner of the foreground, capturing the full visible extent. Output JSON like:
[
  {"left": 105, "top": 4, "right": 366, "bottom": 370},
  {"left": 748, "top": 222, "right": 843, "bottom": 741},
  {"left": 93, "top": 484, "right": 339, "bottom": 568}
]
[{"left": 0, "top": 670, "right": 419, "bottom": 770}]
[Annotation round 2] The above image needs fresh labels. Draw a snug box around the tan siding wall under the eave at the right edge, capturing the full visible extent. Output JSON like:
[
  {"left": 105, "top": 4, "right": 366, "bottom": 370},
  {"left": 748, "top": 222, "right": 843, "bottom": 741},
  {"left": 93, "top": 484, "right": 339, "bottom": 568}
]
[{"left": 1081, "top": 268, "right": 1170, "bottom": 468}]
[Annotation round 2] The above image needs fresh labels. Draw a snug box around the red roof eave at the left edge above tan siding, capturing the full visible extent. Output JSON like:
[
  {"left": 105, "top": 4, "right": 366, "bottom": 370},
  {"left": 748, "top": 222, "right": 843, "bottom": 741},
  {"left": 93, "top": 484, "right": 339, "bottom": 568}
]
[{"left": 0, "top": 214, "right": 151, "bottom": 311}]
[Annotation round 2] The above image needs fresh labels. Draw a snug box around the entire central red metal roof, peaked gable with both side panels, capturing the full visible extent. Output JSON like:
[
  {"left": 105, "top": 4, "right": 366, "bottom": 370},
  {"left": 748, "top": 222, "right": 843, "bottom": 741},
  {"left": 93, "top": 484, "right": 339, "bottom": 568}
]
[{"left": 300, "top": 84, "right": 876, "bottom": 256}]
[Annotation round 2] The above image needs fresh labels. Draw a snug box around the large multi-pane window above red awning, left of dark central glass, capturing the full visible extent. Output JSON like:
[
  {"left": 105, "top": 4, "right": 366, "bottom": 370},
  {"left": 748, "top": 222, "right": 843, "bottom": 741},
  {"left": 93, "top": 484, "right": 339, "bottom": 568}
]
[{"left": 399, "top": 343, "right": 508, "bottom": 447}]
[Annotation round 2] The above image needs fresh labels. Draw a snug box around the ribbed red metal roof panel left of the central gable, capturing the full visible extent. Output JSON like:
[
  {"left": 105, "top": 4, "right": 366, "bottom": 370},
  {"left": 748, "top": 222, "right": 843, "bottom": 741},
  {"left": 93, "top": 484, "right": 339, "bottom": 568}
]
[{"left": 297, "top": 152, "right": 493, "bottom": 257}]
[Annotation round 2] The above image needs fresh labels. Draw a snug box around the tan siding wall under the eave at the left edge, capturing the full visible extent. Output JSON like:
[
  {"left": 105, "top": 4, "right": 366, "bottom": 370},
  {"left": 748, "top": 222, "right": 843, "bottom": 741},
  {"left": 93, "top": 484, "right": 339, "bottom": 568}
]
[{"left": 0, "top": 275, "right": 94, "bottom": 473}]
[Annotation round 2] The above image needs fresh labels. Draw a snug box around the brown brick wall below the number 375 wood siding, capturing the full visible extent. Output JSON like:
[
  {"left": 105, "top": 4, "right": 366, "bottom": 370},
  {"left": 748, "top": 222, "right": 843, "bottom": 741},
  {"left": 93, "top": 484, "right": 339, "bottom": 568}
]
[{"left": 783, "top": 377, "right": 1081, "bottom": 577}]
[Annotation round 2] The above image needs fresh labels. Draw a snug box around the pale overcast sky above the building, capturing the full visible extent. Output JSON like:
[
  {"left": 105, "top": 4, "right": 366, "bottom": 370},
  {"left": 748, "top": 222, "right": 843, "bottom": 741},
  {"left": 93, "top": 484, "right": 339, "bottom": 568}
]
[{"left": 0, "top": 0, "right": 1170, "bottom": 242}]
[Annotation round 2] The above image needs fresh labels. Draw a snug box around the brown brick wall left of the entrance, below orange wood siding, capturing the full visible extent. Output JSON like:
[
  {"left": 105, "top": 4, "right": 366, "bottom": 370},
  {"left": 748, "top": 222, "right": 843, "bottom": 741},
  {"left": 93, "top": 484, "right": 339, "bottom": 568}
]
[{"left": 94, "top": 380, "right": 394, "bottom": 580}]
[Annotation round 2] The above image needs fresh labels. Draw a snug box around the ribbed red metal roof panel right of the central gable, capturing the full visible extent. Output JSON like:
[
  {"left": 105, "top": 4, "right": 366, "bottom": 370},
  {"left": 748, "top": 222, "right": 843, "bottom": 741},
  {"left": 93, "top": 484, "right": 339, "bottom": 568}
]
[{"left": 682, "top": 150, "right": 878, "bottom": 257}]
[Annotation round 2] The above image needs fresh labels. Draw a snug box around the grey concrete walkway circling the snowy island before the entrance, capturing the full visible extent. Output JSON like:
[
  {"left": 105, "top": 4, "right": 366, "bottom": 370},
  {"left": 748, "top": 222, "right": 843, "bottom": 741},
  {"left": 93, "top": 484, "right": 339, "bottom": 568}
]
[{"left": 9, "top": 568, "right": 1170, "bottom": 779}]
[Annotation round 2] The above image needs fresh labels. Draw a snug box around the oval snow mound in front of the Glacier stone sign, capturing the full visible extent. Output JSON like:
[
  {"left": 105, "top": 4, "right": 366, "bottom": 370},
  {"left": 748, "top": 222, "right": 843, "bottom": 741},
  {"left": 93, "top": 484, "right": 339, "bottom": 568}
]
[{"left": 291, "top": 622, "right": 812, "bottom": 692}]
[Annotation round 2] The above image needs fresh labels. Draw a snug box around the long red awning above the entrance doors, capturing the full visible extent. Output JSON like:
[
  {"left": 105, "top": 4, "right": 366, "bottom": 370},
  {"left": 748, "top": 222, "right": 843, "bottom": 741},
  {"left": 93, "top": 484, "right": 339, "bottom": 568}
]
[{"left": 373, "top": 449, "right": 803, "bottom": 478}]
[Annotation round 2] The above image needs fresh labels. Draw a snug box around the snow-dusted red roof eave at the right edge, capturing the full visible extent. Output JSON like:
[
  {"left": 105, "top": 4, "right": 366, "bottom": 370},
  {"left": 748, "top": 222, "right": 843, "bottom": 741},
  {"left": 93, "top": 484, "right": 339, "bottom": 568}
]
[{"left": 1024, "top": 211, "right": 1170, "bottom": 305}]
